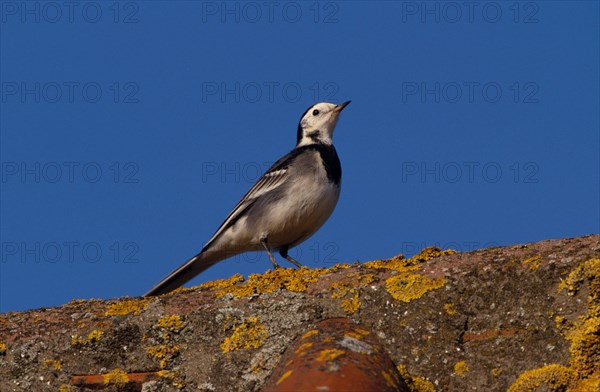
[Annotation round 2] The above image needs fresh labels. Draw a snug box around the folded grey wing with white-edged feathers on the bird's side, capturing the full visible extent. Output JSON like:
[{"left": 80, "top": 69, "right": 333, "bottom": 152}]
[{"left": 204, "top": 167, "right": 289, "bottom": 249}]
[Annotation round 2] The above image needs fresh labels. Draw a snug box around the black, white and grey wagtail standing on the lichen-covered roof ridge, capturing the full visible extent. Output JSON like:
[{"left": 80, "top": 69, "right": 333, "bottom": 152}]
[{"left": 144, "top": 101, "right": 350, "bottom": 297}]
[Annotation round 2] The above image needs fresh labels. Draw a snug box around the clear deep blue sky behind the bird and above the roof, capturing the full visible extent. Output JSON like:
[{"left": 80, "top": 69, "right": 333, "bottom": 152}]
[{"left": 0, "top": 1, "right": 600, "bottom": 312}]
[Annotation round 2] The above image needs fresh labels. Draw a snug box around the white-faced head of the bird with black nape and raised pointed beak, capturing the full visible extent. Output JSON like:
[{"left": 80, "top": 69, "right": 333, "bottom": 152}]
[{"left": 296, "top": 101, "right": 350, "bottom": 147}]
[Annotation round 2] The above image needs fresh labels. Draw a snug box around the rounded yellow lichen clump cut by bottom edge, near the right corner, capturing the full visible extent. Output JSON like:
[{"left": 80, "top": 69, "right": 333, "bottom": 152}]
[{"left": 508, "top": 364, "right": 574, "bottom": 392}]
